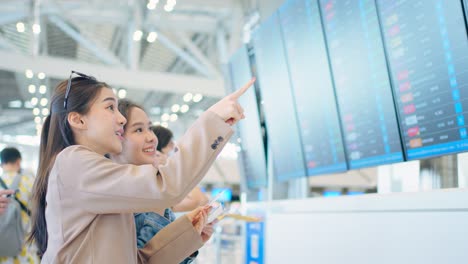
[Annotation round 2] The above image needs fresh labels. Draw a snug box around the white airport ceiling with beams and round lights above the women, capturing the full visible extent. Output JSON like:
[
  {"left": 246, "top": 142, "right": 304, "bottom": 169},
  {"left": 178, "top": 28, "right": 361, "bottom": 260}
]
[{"left": 0, "top": 0, "right": 254, "bottom": 139}]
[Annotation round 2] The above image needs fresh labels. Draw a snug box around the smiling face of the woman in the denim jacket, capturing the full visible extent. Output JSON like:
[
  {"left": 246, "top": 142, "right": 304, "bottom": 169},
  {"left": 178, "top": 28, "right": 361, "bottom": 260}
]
[{"left": 117, "top": 107, "right": 158, "bottom": 165}]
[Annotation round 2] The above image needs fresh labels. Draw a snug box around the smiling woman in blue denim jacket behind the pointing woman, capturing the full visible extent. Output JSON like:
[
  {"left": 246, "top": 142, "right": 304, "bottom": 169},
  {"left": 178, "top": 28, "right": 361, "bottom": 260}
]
[{"left": 111, "top": 100, "right": 213, "bottom": 264}]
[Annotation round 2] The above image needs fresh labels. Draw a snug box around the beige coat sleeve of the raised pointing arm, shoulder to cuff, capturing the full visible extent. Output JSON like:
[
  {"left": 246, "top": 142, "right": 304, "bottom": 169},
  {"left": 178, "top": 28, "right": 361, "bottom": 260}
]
[{"left": 56, "top": 112, "right": 233, "bottom": 213}]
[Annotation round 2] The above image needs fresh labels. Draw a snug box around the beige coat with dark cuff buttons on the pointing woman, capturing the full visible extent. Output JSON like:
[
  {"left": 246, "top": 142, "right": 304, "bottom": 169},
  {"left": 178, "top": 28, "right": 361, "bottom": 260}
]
[{"left": 42, "top": 112, "right": 233, "bottom": 264}]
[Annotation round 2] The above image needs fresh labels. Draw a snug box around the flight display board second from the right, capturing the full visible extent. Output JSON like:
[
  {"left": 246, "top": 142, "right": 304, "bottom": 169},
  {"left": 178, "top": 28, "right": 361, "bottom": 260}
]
[{"left": 320, "top": 0, "right": 403, "bottom": 169}]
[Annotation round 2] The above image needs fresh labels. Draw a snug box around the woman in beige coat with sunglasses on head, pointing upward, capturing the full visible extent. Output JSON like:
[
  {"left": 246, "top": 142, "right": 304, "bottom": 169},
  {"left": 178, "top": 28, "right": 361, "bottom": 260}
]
[{"left": 30, "top": 70, "right": 251, "bottom": 264}]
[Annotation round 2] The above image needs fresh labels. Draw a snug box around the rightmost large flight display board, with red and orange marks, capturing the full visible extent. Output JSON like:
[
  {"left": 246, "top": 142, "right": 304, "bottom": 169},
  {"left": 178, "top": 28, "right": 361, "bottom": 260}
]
[{"left": 377, "top": 0, "right": 468, "bottom": 160}]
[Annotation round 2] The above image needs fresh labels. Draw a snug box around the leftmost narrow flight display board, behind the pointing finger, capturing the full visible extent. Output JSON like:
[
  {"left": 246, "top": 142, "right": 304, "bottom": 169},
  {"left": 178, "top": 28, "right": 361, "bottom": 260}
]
[{"left": 229, "top": 46, "right": 268, "bottom": 188}]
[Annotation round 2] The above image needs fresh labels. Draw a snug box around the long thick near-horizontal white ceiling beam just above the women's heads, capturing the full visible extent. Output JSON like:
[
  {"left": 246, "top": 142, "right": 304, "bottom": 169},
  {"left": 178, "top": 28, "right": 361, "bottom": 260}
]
[{"left": 0, "top": 51, "right": 225, "bottom": 98}]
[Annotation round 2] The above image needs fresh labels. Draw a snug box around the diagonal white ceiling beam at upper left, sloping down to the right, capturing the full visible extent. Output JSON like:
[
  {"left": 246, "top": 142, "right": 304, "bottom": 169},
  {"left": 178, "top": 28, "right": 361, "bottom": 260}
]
[{"left": 49, "top": 15, "right": 124, "bottom": 67}]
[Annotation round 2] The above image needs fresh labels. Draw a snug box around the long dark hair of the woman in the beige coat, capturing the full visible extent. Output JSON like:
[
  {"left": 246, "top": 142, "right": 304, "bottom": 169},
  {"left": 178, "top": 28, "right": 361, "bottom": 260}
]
[{"left": 28, "top": 77, "right": 109, "bottom": 257}]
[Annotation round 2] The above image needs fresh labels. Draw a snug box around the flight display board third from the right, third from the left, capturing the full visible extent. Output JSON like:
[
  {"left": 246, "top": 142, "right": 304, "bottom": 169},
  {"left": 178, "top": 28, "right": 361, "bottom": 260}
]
[{"left": 279, "top": 0, "right": 347, "bottom": 176}]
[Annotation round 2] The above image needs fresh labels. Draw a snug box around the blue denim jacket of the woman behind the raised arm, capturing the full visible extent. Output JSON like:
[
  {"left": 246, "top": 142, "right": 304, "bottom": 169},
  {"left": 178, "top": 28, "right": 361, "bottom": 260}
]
[{"left": 135, "top": 208, "right": 198, "bottom": 264}]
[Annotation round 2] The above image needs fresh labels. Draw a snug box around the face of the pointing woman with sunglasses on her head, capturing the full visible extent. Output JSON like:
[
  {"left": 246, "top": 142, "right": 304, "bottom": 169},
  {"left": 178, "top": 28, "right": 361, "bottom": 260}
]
[{"left": 77, "top": 88, "right": 127, "bottom": 154}]
